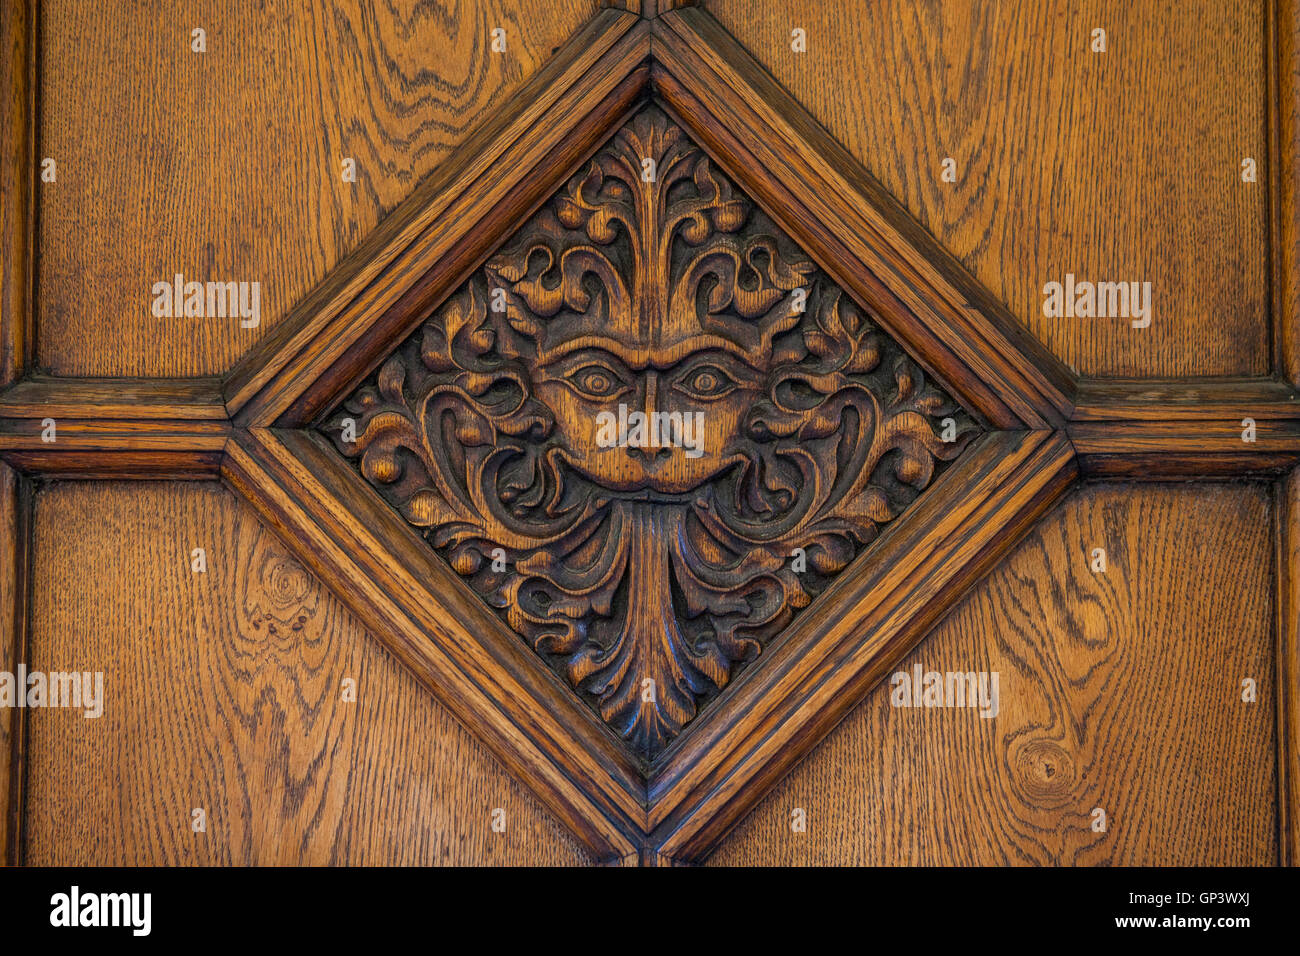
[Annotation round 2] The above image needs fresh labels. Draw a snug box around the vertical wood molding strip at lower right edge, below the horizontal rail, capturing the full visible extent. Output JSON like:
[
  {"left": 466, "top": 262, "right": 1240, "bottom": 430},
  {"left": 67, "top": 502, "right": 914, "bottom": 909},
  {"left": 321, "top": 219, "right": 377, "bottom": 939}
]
[{"left": 1274, "top": 470, "right": 1300, "bottom": 866}]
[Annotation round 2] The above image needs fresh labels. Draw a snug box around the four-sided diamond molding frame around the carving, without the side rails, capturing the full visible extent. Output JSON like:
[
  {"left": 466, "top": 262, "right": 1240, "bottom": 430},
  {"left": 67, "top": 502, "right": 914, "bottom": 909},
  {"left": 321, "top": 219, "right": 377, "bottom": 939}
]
[{"left": 225, "top": 1, "right": 1075, "bottom": 861}]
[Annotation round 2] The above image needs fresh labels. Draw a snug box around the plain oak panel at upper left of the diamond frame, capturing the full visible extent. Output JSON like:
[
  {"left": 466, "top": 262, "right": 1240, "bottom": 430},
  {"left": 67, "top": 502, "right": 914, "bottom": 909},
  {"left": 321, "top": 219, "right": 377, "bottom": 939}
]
[{"left": 36, "top": 0, "right": 599, "bottom": 376}]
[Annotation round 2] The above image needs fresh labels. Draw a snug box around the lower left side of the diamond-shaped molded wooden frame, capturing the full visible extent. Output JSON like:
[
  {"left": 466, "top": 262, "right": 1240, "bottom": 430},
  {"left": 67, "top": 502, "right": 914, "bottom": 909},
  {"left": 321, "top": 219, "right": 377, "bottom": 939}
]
[{"left": 222, "top": 429, "right": 645, "bottom": 861}]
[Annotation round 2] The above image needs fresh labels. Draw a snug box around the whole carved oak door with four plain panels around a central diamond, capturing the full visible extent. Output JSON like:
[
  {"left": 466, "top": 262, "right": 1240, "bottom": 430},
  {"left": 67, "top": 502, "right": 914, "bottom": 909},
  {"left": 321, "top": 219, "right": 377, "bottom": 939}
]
[{"left": 0, "top": 0, "right": 1300, "bottom": 865}]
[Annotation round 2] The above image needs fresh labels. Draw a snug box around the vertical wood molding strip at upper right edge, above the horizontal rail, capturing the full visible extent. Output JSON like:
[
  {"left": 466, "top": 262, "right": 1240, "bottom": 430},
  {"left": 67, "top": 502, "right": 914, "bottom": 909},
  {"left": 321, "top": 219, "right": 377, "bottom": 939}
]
[{"left": 1265, "top": 0, "right": 1300, "bottom": 384}]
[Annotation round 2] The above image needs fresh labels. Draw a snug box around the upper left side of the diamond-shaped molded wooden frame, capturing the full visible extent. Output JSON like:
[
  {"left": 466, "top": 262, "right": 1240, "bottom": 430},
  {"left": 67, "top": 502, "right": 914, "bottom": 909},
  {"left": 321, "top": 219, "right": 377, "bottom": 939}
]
[{"left": 226, "top": 9, "right": 649, "bottom": 424}]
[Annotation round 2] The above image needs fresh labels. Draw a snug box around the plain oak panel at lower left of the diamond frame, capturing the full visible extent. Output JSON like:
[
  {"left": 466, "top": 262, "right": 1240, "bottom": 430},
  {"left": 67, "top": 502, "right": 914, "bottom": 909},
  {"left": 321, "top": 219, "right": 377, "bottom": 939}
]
[{"left": 26, "top": 483, "right": 586, "bottom": 865}]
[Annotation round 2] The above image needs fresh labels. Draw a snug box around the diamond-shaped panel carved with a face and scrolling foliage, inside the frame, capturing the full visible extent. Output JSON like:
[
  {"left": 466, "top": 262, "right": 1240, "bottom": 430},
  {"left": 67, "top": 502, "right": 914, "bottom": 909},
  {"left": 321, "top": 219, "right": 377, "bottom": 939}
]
[{"left": 322, "top": 105, "right": 979, "bottom": 758}]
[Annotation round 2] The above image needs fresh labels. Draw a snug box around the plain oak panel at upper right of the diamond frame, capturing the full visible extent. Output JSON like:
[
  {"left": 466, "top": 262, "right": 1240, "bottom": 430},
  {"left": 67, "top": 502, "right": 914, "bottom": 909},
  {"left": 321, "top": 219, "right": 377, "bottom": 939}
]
[{"left": 706, "top": 0, "right": 1270, "bottom": 376}]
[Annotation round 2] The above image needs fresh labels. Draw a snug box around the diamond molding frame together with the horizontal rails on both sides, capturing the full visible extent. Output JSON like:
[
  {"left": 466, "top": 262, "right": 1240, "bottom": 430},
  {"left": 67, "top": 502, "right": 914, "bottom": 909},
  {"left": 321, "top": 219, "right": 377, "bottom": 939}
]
[{"left": 0, "top": 7, "right": 1300, "bottom": 865}]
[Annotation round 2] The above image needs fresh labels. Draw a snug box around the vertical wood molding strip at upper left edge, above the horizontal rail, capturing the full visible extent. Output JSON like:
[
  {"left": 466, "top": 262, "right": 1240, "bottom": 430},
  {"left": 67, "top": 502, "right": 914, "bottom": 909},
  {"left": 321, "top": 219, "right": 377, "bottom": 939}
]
[{"left": 0, "top": 0, "right": 40, "bottom": 388}]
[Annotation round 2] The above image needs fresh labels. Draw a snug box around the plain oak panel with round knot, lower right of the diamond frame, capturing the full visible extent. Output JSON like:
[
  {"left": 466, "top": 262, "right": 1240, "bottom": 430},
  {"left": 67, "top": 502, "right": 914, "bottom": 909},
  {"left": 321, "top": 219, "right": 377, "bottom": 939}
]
[{"left": 712, "top": 484, "right": 1278, "bottom": 865}]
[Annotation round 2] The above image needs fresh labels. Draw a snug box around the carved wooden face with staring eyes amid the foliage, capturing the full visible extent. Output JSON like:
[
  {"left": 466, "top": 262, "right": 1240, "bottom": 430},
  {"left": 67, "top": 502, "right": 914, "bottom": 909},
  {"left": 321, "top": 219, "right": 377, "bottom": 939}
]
[{"left": 534, "top": 339, "right": 763, "bottom": 494}]
